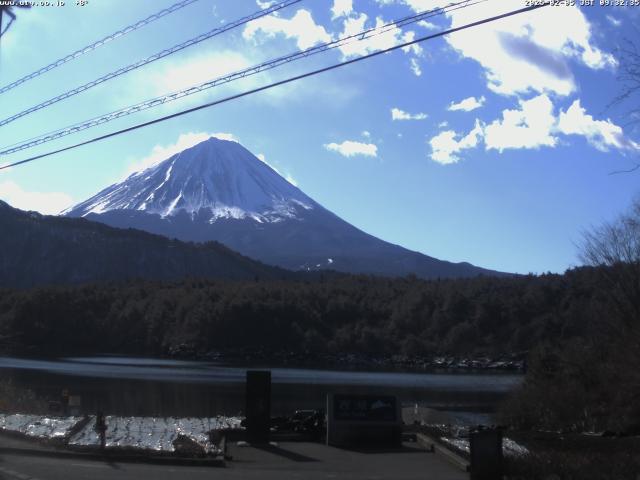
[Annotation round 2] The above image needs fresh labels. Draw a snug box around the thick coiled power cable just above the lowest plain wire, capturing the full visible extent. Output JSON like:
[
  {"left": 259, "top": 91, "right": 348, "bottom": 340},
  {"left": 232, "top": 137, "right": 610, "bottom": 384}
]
[{"left": 0, "top": 0, "right": 480, "bottom": 155}]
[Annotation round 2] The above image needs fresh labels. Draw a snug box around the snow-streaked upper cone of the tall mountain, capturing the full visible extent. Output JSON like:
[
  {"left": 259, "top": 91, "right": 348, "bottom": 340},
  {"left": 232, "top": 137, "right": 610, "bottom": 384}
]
[{"left": 64, "top": 137, "right": 317, "bottom": 223}]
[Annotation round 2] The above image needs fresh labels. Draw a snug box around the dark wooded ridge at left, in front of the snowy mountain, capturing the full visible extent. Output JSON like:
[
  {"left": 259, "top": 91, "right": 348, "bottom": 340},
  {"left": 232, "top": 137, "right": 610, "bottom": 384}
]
[{"left": 0, "top": 201, "right": 291, "bottom": 287}]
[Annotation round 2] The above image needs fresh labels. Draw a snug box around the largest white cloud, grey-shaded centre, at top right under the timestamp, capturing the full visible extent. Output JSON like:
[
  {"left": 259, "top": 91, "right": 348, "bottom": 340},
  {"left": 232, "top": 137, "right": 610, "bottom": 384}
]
[{"left": 378, "top": 0, "right": 616, "bottom": 95}]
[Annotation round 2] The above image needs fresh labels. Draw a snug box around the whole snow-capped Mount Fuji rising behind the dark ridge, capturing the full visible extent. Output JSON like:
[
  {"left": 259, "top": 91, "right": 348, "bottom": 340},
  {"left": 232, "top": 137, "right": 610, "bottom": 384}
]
[{"left": 63, "top": 137, "right": 498, "bottom": 278}]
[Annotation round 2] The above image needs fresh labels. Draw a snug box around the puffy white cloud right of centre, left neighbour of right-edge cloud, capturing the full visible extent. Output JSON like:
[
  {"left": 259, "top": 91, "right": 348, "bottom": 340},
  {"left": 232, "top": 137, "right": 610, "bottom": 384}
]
[{"left": 484, "top": 94, "right": 557, "bottom": 152}]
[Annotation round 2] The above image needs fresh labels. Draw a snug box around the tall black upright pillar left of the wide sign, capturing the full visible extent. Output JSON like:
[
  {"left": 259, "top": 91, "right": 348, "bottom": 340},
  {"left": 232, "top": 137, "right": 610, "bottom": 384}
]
[{"left": 246, "top": 370, "right": 271, "bottom": 443}]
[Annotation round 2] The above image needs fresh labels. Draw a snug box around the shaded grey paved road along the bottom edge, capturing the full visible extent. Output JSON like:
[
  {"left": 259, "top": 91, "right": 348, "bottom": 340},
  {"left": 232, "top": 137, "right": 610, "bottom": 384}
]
[{"left": 0, "top": 443, "right": 469, "bottom": 480}]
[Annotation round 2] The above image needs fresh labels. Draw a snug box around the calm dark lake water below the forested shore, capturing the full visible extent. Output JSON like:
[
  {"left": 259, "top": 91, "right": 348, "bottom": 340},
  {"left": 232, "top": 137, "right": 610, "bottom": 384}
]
[{"left": 0, "top": 356, "right": 522, "bottom": 421}]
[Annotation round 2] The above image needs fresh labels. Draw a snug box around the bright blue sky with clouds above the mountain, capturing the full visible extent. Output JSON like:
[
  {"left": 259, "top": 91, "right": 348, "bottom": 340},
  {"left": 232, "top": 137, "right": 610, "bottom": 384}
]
[{"left": 0, "top": 0, "right": 640, "bottom": 273}]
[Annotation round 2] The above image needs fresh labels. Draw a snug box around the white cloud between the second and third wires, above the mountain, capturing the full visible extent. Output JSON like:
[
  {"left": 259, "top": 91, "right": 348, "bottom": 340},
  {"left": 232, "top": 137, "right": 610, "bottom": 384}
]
[{"left": 242, "top": 9, "right": 331, "bottom": 49}]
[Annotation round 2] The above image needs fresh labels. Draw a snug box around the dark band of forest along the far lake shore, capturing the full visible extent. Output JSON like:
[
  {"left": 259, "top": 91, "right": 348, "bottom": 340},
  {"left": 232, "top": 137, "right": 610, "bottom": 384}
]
[{"left": 0, "top": 268, "right": 606, "bottom": 356}]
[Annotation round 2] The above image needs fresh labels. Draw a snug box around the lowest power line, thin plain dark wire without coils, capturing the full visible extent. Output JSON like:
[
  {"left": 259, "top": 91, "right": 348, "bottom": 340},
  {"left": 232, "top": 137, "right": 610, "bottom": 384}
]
[{"left": 0, "top": 3, "right": 550, "bottom": 170}]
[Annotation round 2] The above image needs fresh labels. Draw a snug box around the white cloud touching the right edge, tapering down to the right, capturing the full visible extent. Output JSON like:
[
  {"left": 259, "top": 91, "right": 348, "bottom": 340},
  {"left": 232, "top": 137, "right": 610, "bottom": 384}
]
[{"left": 557, "top": 100, "right": 640, "bottom": 152}]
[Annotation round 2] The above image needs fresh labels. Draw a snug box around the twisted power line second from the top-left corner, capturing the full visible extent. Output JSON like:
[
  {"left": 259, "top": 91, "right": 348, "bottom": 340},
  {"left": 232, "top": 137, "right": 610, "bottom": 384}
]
[{"left": 0, "top": 0, "right": 302, "bottom": 127}]
